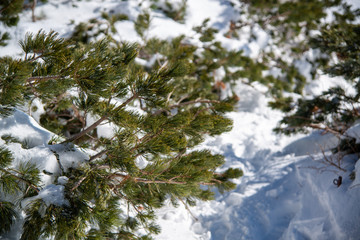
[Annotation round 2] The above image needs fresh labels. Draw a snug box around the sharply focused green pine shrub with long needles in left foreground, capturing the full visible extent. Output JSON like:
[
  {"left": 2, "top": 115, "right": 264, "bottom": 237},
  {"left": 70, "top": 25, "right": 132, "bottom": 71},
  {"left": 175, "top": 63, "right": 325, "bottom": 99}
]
[{"left": 0, "top": 31, "right": 242, "bottom": 239}]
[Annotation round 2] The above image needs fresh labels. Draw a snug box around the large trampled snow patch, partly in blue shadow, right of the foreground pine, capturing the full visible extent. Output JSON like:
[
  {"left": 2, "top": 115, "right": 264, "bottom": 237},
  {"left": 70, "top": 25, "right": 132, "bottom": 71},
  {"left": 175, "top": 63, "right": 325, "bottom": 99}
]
[{"left": 158, "top": 81, "right": 360, "bottom": 240}]
